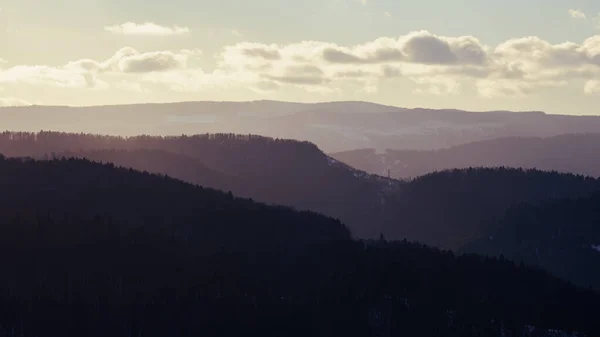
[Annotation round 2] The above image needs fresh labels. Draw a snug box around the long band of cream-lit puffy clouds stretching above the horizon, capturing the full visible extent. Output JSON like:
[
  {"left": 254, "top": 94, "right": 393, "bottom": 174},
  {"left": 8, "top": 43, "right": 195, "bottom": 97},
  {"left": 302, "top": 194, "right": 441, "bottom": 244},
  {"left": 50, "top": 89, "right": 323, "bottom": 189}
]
[{"left": 0, "top": 31, "right": 600, "bottom": 97}]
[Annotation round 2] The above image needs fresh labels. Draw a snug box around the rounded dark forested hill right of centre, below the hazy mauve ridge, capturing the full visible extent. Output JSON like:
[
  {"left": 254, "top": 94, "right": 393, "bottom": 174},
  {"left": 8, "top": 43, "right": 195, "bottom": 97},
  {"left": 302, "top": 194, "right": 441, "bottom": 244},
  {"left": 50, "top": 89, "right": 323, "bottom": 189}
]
[{"left": 383, "top": 167, "right": 600, "bottom": 249}]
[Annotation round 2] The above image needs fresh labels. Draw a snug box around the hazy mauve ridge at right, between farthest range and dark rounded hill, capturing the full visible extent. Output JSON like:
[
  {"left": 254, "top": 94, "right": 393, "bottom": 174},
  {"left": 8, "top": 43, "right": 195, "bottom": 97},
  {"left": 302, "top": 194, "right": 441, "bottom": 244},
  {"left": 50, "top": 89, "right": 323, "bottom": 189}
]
[{"left": 331, "top": 133, "right": 600, "bottom": 179}]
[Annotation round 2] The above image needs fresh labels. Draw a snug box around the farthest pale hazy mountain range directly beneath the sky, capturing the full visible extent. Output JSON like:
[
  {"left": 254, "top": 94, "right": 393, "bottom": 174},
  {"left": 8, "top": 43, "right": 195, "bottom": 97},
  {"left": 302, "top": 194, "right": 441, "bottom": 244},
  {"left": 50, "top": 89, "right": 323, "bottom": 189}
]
[{"left": 0, "top": 101, "right": 600, "bottom": 152}]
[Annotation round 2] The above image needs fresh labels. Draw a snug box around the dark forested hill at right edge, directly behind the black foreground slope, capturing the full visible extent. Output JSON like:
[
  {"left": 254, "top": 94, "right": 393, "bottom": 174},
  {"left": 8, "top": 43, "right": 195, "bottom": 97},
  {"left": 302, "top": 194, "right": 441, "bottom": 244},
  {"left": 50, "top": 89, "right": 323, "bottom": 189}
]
[{"left": 462, "top": 193, "right": 600, "bottom": 289}]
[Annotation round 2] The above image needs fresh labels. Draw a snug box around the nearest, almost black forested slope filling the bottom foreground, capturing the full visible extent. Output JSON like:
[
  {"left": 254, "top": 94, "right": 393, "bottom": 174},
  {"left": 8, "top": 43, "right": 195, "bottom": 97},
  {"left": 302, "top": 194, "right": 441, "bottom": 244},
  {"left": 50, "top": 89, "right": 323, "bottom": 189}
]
[{"left": 0, "top": 158, "right": 600, "bottom": 337}]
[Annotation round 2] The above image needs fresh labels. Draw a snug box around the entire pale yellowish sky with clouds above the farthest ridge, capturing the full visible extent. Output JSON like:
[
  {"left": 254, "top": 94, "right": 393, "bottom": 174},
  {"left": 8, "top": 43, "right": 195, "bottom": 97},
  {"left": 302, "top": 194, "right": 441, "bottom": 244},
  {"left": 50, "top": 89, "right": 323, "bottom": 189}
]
[{"left": 0, "top": 0, "right": 600, "bottom": 115}]
